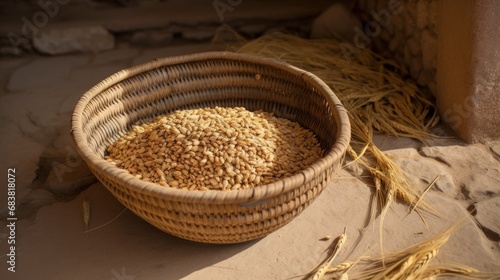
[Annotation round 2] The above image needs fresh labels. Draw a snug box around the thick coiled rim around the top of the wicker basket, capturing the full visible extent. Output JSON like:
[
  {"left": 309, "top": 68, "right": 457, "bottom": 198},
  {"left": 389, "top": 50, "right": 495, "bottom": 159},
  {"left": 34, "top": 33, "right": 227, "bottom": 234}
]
[{"left": 71, "top": 51, "right": 351, "bottom": 205}]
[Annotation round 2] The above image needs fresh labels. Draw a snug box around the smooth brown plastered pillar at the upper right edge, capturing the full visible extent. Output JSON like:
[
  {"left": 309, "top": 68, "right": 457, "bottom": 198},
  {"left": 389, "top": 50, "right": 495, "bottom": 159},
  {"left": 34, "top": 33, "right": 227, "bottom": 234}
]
[{"left": 437, "top": 0, "right": 500, "bottom": 142}]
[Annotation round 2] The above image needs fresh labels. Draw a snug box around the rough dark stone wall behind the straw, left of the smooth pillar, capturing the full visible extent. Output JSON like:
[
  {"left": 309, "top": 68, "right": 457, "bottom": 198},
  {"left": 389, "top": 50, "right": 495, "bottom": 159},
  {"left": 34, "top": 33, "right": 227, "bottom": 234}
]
[{"left": 354, "top": 0, "right": 438, "bottom": 94}]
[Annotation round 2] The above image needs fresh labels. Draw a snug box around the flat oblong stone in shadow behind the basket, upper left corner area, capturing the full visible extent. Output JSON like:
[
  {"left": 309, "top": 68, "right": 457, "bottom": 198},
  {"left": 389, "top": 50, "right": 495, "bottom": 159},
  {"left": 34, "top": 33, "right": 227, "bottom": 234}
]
[{"left": 33, "top": 26, "right": 115, "bottom": 55}]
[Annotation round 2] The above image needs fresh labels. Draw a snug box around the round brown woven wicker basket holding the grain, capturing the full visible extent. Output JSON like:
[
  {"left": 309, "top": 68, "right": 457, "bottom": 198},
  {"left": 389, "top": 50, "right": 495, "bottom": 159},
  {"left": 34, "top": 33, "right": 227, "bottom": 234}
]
[{"left": 72, "top": 52, "right": 350, "bottom": 243}]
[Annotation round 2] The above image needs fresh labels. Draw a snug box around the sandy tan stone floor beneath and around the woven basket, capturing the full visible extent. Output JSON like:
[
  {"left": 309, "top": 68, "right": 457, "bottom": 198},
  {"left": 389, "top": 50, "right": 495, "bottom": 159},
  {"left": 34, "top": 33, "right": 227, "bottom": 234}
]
[{"left": 0, "top": 41, "right": 500, "bottom": 280}]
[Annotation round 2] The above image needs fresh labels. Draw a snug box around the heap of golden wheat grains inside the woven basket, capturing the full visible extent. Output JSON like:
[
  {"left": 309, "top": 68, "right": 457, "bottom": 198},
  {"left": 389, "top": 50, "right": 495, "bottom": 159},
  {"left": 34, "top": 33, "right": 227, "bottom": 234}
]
[{"left": 106, "top": 107, "right": 323, "bottom": 190}]
